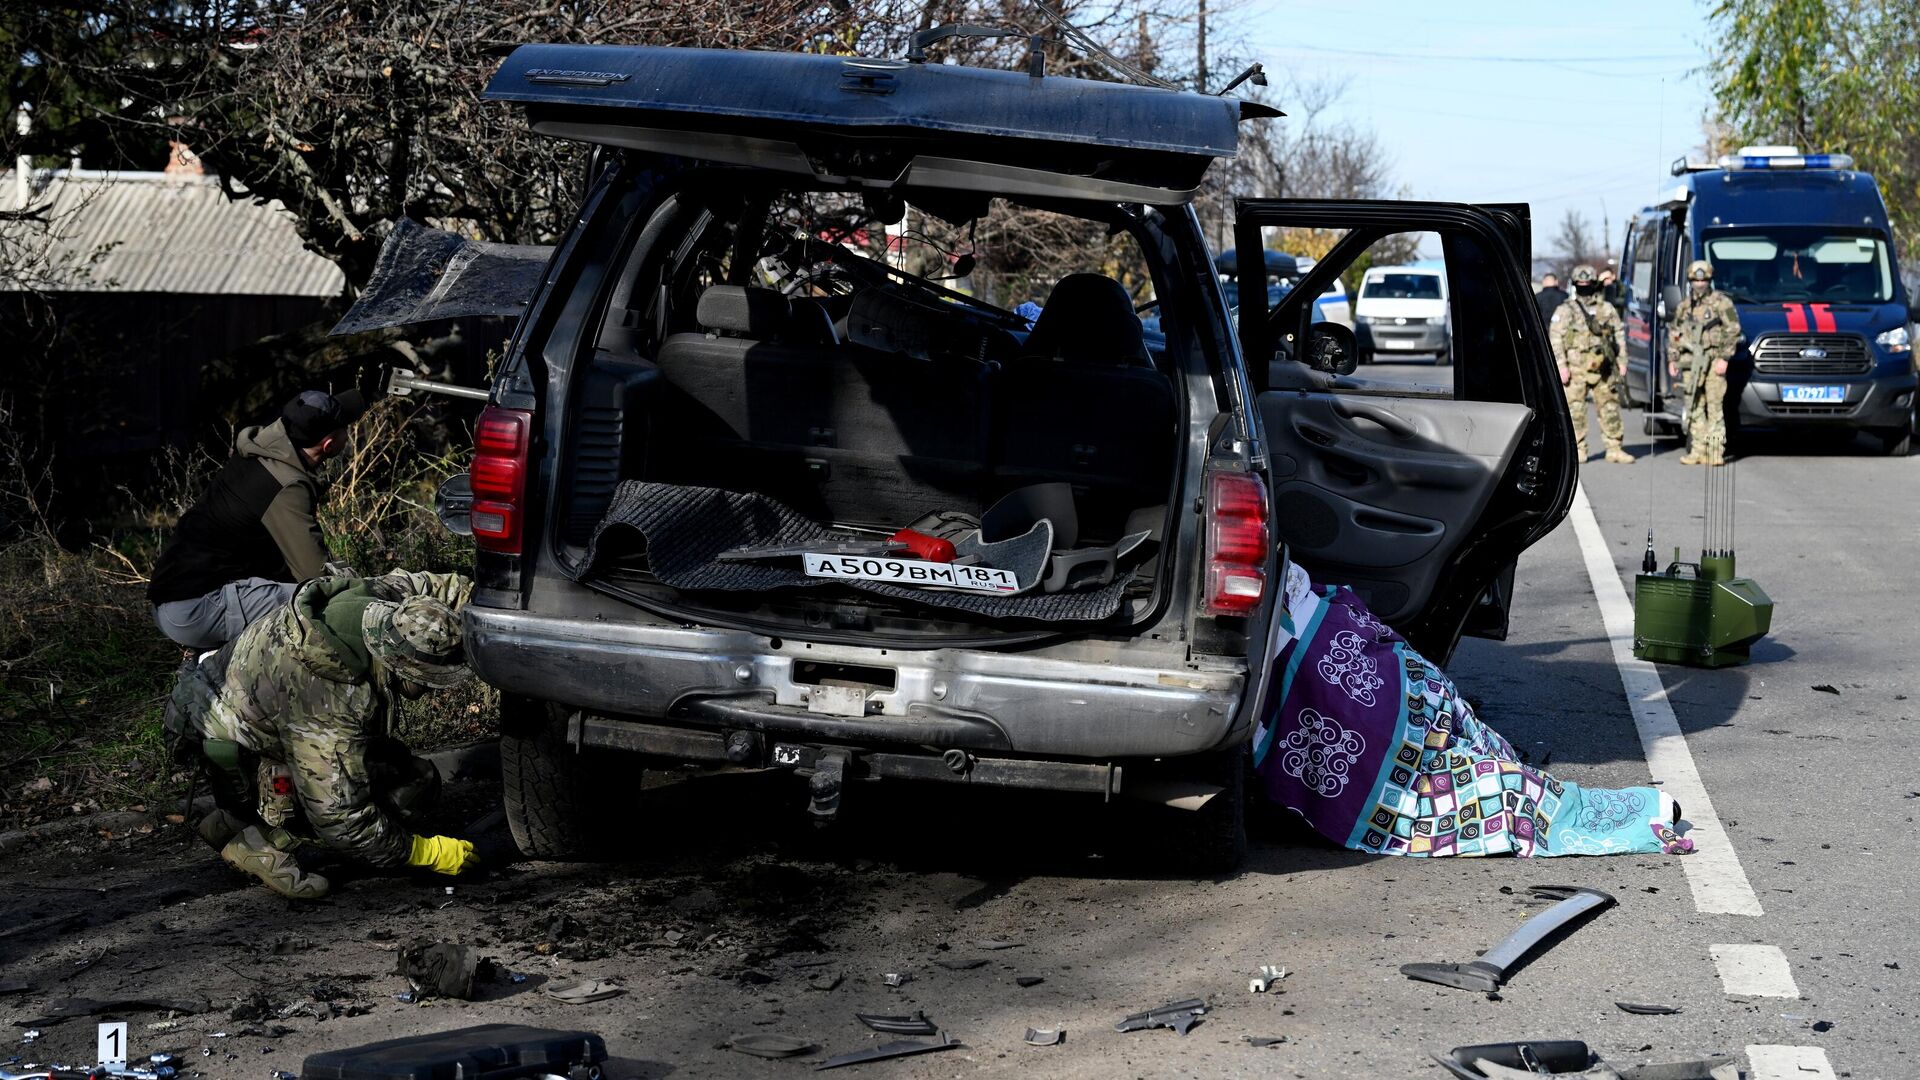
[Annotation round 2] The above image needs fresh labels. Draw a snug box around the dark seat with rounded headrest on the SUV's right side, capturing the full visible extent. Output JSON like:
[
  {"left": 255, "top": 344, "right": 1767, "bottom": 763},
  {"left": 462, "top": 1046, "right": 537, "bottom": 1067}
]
[{"left": 993, "top": 273, "right": 1177, "bottom": 532}]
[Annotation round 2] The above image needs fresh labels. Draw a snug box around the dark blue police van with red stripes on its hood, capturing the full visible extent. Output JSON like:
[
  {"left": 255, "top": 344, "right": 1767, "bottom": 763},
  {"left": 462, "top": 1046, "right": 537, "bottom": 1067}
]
[{"left": 1620, "top": 146, "right": 1916, "bottom": 454}]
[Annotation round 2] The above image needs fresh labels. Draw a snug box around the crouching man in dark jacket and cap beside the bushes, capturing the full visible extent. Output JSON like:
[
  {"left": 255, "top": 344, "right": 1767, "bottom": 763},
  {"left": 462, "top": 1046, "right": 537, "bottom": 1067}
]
[{"left": 146, "top": 390, "right": 367, "bottom": 650}]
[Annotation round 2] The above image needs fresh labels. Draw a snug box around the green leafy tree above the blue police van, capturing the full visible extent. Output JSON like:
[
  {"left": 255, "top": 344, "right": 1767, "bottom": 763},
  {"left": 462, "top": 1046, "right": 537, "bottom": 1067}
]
[{"left": 1709, "top": 0, "right": 1920, "bottom": 256}]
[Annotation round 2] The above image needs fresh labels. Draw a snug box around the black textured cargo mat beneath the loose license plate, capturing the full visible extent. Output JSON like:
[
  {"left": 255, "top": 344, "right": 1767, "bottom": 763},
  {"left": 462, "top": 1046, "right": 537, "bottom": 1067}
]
[{"left": 574, "top": 480, "right": 1133, "bottom": 623}]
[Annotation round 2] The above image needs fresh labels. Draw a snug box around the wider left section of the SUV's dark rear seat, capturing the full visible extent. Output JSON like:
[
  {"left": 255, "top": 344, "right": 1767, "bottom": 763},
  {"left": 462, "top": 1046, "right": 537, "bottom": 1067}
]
[{"left": 649, "top": 284, "right": 989, "bottom": 523}]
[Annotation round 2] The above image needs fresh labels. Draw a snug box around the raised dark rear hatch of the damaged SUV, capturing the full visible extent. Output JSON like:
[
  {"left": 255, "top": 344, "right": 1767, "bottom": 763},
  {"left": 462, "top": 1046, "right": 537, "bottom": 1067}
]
[{"left": 486, "top": 44, "right": 1242, "bottom": 204}]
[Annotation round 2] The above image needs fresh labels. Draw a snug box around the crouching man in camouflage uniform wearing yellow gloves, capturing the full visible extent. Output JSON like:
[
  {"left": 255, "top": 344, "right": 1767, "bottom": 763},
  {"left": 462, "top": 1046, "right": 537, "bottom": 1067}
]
[{"left": 167, "top": 571, "right": 476, "bottom": 899}]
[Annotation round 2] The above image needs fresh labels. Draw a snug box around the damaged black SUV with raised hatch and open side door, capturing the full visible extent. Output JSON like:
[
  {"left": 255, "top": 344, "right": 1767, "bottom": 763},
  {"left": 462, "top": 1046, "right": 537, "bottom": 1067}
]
[{"left": 344, "top": 46, "right": 1574, "bottom": 869}]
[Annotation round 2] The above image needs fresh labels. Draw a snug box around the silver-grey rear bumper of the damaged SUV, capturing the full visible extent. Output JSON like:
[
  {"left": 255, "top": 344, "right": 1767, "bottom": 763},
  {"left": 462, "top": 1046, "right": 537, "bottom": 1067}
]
[{"left": 467, "top": 605, "right": 1246, "bottom": 761}]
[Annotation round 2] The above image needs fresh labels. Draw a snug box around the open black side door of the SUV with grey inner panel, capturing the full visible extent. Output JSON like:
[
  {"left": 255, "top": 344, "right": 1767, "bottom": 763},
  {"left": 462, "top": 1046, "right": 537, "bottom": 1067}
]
[{"left": 1235, "top": 200, "right": 1576, "bottom": 663}]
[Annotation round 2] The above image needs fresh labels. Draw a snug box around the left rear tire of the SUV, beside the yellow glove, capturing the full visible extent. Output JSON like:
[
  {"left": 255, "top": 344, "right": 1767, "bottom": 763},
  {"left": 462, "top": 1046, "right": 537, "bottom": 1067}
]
[{"left": 499, "top": 696, "right": 618, "bottom": 859}]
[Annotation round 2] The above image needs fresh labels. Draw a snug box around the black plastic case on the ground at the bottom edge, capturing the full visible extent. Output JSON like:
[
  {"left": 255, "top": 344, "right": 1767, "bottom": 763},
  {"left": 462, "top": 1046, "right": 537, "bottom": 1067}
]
[{"left": 300, "top": 1024, "right": 607, "bottom": 1080}]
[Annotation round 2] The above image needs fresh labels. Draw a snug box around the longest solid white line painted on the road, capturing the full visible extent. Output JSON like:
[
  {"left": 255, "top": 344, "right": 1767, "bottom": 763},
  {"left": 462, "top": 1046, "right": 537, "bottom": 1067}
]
[{"left": 1567, "top": 486, "right": 1763, "bottom": 915}]
